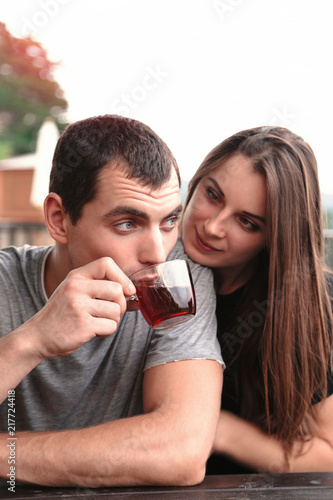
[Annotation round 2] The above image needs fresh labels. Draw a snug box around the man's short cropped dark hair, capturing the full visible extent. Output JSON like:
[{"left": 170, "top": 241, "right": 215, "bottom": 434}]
[{"left": 49, "top": 115, "right": 180, "bottom": 224}]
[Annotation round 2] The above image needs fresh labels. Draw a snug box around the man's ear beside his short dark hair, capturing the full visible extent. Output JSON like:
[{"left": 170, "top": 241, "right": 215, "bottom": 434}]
[{"left": 44, "top": 193, "right": 69, "bottom": 244}]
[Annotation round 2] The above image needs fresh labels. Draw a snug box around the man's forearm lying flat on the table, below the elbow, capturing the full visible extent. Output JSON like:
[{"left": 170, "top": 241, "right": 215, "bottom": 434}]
[{"left": 0, "top": 408, "right": 205, "bottom": 487}]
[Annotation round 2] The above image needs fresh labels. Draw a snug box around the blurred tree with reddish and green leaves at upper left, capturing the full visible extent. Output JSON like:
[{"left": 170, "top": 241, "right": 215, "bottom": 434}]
[{"left": 0, "top": 23, "right": 68, "bottom": 159}]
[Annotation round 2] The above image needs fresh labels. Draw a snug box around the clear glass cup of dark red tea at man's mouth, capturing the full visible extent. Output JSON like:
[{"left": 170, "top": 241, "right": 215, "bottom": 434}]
[{"left": 127, "top": 260, "right": 196, "bottom": 329}]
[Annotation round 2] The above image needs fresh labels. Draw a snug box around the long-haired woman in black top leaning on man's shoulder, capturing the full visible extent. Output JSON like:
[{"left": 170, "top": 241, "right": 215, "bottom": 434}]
[{"left": 182, "top": 127, "right": 333, "bottom": 474}]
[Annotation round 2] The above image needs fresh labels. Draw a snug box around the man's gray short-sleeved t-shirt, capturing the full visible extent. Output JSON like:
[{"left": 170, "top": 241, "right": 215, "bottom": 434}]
[{"left": 0, "top": 240, "right": 223, "bottom": 431}]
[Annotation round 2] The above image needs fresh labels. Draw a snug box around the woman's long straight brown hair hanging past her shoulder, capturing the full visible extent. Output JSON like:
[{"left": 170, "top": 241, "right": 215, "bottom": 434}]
[{"left": 185, "top": 127, "right": 332, "bottom": 453}]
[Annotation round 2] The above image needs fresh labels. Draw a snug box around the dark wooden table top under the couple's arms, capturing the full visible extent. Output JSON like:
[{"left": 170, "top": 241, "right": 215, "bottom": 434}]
[{"left": 0, "top": 472, "right": 333, "bottom": 500}]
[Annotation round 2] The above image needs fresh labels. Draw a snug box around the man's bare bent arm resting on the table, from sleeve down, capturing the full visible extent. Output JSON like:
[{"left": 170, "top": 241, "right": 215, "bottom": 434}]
[{"left": 0, "top": 360, "right": 222, "bottom": 487}]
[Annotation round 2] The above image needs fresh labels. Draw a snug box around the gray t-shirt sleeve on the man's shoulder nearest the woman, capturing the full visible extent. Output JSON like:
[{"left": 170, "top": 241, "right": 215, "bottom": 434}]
[{"left": 145, "top": 242, "right": 224, "bottom": 370}]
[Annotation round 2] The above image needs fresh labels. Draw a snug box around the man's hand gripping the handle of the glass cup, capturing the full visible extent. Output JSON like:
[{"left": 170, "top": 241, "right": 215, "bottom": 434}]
[{"left": 25, "top": 257, "right": 135, "bottom": 358}]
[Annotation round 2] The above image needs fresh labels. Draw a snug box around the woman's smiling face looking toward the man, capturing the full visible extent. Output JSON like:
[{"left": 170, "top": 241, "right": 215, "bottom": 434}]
[{"left": 183, "top": 153, "right": 266, "bottom": 286}]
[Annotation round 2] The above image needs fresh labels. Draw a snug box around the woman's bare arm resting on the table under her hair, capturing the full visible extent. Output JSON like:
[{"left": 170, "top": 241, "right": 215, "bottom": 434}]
[{"left": 214, "top": 395, "right": 333, "bottom": 474}]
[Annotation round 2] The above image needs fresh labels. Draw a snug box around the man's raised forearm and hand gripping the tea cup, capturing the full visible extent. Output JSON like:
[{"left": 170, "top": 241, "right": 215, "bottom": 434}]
[{"left": 0, "top": 258, "right": 135, "bottom": 403}]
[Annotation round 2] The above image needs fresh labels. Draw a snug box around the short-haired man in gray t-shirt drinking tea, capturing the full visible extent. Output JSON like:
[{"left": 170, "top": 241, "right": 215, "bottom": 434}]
[{"left": 0, "top": 115, "right": 222, "bottom": 487}]
